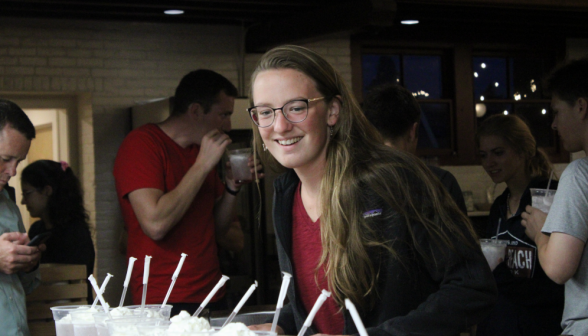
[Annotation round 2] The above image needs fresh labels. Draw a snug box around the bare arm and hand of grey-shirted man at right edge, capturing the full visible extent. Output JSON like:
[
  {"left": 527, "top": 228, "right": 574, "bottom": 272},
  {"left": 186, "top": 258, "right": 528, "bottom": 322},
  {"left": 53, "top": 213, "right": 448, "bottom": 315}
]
[{"left": 521, "top": 205, "right": 585, "bottom": 285}]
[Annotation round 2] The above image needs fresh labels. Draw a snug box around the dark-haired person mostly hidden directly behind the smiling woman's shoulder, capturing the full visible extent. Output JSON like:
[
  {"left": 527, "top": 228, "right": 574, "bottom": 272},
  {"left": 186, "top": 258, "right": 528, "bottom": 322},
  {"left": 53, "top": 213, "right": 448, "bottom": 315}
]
[{"left": 363, "top": 83, "right": 467, "bottom": 214}]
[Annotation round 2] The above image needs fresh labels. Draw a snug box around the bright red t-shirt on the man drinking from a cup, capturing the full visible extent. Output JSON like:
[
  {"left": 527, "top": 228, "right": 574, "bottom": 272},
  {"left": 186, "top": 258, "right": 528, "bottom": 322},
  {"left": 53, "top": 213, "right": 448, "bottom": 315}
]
[{"left": 114, "top": 124, "right": 224, "bottom": 304}]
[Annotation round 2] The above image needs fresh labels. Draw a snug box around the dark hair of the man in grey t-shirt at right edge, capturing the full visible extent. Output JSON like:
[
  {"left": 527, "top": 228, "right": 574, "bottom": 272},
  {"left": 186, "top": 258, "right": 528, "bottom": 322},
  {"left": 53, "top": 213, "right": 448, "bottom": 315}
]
[{"left": 544, "top": 57, "right": 588, "bottom": 106}]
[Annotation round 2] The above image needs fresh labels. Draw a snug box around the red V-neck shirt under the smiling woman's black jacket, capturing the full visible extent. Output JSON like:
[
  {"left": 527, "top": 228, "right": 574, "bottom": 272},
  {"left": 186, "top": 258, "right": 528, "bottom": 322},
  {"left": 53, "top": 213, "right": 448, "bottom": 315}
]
[{"left": 292, "top": 184, "right": 344, "bottom": 335}]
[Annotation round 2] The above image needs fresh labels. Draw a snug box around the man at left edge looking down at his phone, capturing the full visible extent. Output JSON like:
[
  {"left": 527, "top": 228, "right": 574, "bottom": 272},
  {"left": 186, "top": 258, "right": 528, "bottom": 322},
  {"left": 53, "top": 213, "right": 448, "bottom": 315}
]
[{"left": 0, "top": 99, "right": 45, "bottom": 336}]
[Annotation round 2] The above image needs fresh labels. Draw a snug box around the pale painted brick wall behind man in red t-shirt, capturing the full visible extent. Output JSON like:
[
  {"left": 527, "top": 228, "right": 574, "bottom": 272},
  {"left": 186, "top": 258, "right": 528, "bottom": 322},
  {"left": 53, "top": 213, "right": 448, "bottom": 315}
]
[{"left": 0, "top": 18, "right": 351, "bottom": 304}]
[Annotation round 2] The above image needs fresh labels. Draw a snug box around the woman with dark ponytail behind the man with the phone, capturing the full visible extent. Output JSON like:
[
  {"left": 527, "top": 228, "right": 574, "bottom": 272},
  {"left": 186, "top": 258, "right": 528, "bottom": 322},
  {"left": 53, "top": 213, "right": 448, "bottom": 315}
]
[{"left": 20, "top": 160, "right": 95, "bottom": 302}]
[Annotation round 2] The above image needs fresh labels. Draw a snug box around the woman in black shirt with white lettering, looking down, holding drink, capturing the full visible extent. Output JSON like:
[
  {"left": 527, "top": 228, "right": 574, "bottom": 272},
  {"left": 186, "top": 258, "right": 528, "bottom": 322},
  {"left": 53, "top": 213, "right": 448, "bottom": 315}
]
[{"left": 476, "top": 114, "right": 564, "bottom": 336}]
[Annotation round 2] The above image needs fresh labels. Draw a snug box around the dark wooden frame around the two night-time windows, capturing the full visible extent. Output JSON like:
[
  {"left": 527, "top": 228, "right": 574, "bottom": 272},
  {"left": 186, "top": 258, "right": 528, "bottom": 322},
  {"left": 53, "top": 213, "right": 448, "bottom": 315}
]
[{"left": 351, "top": 38, "right": 570, "bottom": 166}]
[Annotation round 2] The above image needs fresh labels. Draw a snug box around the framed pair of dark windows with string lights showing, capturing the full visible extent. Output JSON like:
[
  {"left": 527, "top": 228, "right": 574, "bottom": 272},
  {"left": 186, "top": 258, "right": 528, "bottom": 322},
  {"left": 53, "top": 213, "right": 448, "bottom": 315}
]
[{"left": 351, "top": 40, "right": 569, "bottom": 165}]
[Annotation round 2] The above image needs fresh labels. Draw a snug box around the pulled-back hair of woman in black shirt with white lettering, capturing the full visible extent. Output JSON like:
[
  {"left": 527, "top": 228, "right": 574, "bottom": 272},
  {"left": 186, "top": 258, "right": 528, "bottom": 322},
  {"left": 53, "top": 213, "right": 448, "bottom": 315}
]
[{"left": 476, "top": 114, "right": 557, "bottom": 178}]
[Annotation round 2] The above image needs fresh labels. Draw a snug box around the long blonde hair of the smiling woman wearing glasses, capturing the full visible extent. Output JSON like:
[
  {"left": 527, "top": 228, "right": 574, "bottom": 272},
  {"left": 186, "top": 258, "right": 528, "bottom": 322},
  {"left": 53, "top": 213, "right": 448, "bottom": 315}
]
[{"left": 250, "top": 46, "right": 476, "bottom": 309}]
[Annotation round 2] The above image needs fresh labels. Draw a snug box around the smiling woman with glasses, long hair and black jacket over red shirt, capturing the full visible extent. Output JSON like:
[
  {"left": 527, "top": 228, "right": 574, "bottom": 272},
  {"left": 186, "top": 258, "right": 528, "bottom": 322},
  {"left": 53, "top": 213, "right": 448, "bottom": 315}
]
[{"left": 249, "top": 46, "right": 496, "bottom": 335}]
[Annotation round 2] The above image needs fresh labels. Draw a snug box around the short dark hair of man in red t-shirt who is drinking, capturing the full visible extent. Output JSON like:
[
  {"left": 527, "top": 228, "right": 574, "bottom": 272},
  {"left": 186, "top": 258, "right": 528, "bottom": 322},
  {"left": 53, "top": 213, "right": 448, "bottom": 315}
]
[{"left": 172, "top": 69, "right": 237, "bottom": 115}]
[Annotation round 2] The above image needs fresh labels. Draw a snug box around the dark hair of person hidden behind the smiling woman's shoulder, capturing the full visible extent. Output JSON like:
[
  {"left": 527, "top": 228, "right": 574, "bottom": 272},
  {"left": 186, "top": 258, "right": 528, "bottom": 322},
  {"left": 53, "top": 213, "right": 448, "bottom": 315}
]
[{"left": 363, "top": 83, "right": 421, "bottom": 140}]
